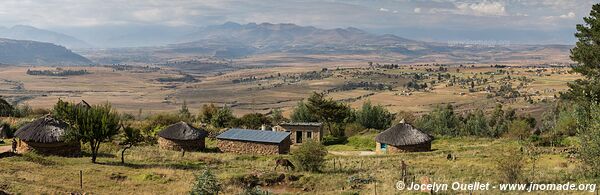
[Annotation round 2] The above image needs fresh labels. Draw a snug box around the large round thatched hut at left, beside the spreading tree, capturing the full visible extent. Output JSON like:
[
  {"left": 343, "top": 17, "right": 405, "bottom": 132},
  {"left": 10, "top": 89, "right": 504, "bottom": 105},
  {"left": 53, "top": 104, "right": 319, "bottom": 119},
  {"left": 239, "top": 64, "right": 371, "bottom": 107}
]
[{"left": 15, "top": 115, "right": 81, "bottom": 156}]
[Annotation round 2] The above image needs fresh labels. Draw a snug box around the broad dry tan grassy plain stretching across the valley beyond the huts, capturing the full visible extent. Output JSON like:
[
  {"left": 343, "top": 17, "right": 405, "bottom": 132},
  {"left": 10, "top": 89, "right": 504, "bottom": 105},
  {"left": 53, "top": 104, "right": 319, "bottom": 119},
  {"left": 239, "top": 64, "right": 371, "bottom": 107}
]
[{"left": 0, "top": 63, "right": 578, "bottom": 119}]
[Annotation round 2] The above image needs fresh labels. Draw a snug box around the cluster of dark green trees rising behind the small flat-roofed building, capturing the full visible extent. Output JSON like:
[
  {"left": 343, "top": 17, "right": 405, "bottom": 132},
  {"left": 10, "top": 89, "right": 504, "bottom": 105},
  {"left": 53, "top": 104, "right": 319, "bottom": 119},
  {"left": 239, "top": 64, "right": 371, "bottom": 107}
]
[{"left": 291, "top": 92, "right": 394, "bottom": 137}]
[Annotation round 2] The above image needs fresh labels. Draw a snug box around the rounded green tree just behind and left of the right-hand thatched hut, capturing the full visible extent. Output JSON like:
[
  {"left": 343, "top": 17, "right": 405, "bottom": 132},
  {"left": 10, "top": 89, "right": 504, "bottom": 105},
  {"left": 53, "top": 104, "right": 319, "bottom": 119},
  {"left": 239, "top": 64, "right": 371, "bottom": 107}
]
[{"left": 356, "top": 101, "right": 394, "bottom": 130}]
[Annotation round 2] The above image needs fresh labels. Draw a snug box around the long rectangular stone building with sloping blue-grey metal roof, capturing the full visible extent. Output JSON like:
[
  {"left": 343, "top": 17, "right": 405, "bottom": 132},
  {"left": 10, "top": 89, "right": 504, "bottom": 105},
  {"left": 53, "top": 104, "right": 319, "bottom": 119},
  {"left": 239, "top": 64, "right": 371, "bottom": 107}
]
[{"left": 217, "top": 129, "right": 292, "bottom": 154}]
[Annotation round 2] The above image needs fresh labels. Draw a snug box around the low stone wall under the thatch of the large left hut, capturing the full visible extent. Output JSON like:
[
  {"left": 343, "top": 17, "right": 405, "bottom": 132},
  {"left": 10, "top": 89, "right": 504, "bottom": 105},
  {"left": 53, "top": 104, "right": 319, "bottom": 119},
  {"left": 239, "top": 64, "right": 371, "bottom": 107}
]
[{"left": 17, "top": 141, "right": 81, "bottom": 156}]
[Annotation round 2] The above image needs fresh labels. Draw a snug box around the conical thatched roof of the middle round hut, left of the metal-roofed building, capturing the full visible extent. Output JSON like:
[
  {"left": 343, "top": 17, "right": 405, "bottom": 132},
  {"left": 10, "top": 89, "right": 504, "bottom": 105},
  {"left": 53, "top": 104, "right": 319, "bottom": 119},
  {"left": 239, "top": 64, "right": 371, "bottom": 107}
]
[{"left": 158, "top": 121, "right": 208, "bottom": 140}]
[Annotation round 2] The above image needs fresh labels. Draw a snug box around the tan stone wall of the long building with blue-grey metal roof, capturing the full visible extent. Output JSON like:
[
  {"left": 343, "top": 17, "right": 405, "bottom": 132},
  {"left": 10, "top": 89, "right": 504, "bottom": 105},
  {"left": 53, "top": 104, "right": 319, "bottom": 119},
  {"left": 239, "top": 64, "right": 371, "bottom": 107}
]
[{"left": 217, "top": 139, "right": 291, "bottom": 155}]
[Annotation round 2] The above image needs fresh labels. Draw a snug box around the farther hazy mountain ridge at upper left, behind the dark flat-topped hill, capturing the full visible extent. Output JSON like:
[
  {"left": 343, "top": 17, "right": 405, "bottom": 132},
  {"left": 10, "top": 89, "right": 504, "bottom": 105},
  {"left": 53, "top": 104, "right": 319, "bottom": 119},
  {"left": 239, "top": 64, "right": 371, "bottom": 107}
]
[{"left": 0, "top": 25, "right": 92, "bottom": 49}]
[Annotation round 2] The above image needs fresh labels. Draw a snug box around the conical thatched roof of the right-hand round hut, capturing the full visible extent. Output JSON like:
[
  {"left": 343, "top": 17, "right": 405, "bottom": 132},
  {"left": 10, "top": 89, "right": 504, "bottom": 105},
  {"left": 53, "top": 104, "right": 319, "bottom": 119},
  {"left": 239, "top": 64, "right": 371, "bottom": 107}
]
[{"left": 375, "top": 123, "right": 433, "bottom": 146}]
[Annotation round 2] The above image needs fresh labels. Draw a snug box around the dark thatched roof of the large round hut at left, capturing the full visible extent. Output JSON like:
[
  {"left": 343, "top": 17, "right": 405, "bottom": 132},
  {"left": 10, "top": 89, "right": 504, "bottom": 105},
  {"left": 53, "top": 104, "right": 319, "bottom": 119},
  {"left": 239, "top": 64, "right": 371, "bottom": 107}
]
[{"left": 15, "top": 115, "right": 68, "bottom": 143}]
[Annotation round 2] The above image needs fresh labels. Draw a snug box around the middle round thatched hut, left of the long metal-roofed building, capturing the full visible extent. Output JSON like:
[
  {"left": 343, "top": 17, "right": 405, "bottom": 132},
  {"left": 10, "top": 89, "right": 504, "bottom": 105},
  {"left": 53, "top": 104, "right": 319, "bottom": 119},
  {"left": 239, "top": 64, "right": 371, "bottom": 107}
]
[{"left": 158, "top": 122, "right": 208, "bottom": 151}]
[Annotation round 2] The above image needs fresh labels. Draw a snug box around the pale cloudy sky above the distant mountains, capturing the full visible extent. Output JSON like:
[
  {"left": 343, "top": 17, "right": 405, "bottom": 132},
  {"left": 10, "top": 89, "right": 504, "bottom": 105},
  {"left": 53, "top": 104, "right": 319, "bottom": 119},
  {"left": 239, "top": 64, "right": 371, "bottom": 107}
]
[{"left": 0, "top": 0, "right": 600, "bottom": 44}]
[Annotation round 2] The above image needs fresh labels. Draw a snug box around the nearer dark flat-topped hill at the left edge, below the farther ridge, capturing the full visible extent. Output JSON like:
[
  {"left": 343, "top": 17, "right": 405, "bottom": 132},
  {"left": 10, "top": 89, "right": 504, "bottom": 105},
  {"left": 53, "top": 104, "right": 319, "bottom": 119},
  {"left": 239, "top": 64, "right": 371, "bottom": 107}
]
[{"left": 0, "top": 39, "right": 92, "bottom": 65}]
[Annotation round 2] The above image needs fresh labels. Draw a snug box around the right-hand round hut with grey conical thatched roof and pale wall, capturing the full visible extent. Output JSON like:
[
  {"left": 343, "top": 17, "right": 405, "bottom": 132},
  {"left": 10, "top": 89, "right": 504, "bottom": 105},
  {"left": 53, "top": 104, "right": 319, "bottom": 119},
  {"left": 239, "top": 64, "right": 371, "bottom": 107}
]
[{"left": 375, "top": 122, "right": 433, "bottom": 154}]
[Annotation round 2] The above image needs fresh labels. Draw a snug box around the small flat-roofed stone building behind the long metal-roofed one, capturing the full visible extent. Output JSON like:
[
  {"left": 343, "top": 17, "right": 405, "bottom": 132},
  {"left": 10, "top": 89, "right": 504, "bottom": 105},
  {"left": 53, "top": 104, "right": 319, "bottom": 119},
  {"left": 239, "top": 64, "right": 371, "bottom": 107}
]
[{"left": 273, "top": 123, "right": 323, "bottom": 144}]
